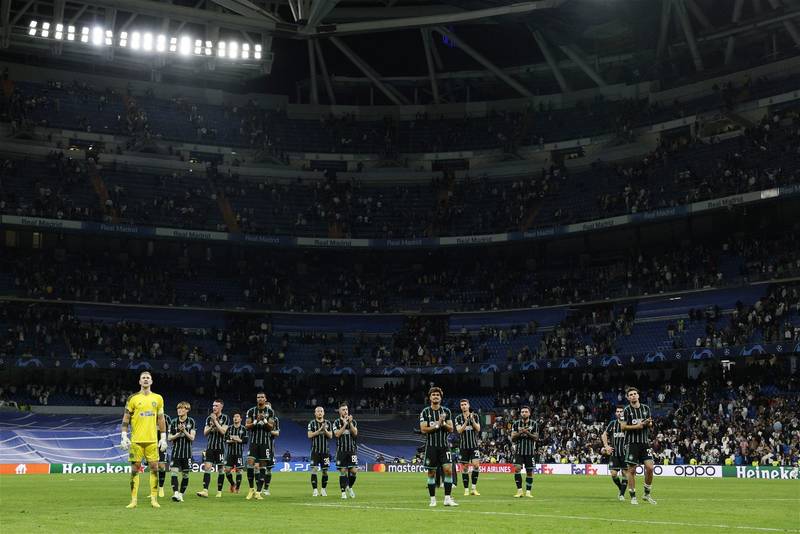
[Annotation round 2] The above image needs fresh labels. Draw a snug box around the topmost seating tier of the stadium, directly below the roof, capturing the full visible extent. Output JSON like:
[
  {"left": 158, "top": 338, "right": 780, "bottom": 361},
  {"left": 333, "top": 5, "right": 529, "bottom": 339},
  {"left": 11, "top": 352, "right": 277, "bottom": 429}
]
[{"left": 3, "top": 73, "right": 800, "bottom": 154}]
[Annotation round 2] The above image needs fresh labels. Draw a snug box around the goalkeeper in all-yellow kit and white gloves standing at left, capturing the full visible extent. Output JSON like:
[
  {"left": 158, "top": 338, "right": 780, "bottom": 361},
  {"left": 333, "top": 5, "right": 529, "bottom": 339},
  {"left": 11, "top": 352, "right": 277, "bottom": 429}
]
[{"left": 120, "top": 371, "right": 167, "bottom": 508}]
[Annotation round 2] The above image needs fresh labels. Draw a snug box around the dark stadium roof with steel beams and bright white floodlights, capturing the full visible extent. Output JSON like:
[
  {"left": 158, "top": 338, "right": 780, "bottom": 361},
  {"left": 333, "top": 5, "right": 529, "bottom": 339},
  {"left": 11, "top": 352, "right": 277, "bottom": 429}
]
[{"left": 0, "top": 0, "right": 800, "bottom": 104}]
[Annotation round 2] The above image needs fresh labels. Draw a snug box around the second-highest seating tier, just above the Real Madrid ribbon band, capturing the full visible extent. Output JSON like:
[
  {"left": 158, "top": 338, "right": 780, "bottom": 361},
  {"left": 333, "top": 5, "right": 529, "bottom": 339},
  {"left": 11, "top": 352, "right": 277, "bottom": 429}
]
[{"left": 0, "top": 114, "right": 800, "bottom": 239}]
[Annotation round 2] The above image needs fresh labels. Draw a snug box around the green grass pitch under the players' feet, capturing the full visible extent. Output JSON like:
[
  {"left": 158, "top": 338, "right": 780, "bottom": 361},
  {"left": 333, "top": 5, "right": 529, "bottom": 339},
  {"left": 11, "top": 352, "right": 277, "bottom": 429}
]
[{"left": 0, "top": 473, "right": 800, "bottom": 534}]
